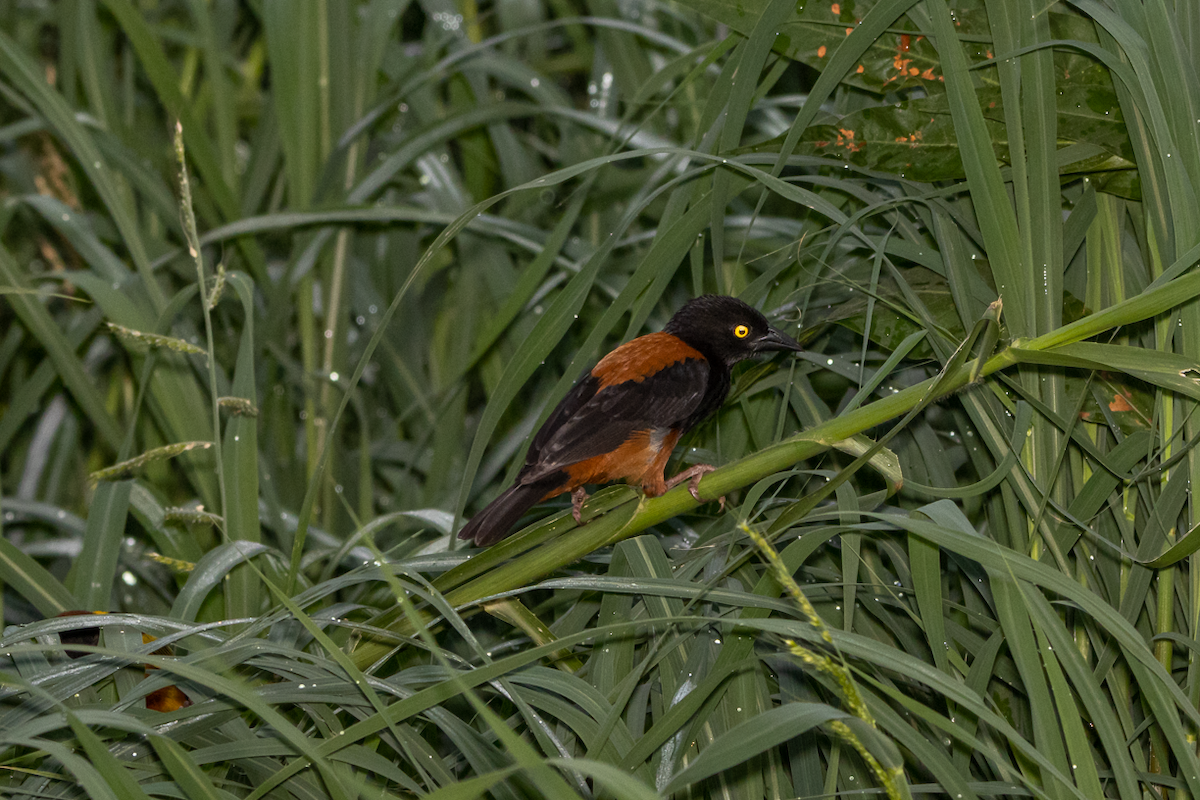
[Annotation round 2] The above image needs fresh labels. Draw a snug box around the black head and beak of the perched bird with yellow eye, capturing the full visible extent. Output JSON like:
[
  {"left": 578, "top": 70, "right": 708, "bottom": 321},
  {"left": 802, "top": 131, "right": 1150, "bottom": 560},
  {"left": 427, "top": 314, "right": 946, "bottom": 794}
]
[{"left": 664, "top": 295, "right": 802, "bottom": 366}]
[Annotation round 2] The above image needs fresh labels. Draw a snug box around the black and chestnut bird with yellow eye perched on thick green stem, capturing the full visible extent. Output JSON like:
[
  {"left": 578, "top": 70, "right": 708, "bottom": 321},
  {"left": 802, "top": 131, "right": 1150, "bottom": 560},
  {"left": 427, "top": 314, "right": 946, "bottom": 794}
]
[{"left": 458, "top": 295, "right": 802, "bottom": 547}]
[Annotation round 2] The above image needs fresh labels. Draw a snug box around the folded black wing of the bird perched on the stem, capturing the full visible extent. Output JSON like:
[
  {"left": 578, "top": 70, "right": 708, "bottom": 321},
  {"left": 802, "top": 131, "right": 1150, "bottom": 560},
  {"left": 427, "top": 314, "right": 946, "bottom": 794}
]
[{"left": 520, "top": 359, "right": 709, "bottom": 483}]
